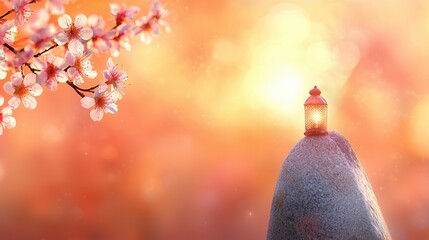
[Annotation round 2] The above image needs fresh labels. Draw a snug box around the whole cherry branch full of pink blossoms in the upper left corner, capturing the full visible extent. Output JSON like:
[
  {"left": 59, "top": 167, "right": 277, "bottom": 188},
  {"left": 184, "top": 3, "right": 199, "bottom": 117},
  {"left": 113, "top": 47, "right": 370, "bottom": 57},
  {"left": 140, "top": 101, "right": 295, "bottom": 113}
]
[{"left": 0, "top": 0, "right": 169, "bottom": 131}]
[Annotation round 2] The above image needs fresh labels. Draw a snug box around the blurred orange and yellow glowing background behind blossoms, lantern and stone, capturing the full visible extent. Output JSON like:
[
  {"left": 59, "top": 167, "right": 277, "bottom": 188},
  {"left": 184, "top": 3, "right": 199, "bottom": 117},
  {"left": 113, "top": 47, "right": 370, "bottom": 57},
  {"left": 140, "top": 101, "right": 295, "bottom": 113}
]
[{"left": 0, "top": 0, "right": 429, "bottom": 240}]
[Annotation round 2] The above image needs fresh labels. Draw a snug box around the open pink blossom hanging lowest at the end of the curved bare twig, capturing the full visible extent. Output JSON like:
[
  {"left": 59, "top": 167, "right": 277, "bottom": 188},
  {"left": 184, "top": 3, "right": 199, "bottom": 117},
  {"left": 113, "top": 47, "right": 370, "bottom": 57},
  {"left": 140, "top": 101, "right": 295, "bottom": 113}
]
[{"left": 80, "top": 84, "right": 118, "bottom": 121}]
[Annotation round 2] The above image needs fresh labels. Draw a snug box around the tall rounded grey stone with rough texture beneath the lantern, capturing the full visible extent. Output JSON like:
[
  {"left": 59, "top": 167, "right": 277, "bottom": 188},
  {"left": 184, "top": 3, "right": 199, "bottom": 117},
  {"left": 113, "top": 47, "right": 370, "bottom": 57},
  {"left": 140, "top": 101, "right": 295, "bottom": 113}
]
[{"left": 267, "top": 132, "right": 391, "bottom": 240}]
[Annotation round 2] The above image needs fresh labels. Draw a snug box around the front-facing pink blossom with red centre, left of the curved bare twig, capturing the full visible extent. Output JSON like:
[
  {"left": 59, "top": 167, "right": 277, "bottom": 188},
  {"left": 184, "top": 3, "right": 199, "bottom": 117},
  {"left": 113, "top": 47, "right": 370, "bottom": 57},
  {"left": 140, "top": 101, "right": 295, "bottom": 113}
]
[{"left": 34, "top": 53, "right": 68, "bottom": 90}]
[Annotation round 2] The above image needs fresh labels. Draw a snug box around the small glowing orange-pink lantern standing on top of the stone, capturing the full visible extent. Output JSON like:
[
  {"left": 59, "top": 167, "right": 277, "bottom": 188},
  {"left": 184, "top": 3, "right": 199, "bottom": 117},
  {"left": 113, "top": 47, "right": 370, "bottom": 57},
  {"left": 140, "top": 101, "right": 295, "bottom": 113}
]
[{"left": 304, "top": 86, "right": 328, "bottom": 136}]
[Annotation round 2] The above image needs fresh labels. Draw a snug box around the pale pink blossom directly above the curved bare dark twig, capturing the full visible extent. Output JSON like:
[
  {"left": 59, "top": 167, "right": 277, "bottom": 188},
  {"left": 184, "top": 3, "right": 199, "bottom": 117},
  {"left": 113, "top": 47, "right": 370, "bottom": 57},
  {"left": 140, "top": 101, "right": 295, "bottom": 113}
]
[{"left": 66, "top": 46, "right": 97, "bottom": 85}]
